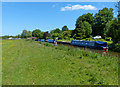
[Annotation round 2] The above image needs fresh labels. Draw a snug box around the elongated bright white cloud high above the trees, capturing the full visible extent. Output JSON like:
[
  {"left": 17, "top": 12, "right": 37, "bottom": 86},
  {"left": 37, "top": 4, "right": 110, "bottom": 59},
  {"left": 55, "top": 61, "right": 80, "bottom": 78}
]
[{"left": 61, "top": 5, "right": 97, "bottom": 11}]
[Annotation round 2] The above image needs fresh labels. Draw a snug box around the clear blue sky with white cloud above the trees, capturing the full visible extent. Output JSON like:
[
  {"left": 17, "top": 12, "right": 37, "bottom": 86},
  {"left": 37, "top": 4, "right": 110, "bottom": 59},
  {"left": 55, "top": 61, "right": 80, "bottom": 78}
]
[{"left": 2, "top": 2, "right": 117, "bottom": 35}]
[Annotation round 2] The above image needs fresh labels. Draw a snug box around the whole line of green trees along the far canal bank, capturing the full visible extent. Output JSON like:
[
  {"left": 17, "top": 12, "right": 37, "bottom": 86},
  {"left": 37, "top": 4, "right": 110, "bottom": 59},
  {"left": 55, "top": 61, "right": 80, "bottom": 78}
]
[{"left": 4, "top": 8, "right": 120, "bottom": 43}]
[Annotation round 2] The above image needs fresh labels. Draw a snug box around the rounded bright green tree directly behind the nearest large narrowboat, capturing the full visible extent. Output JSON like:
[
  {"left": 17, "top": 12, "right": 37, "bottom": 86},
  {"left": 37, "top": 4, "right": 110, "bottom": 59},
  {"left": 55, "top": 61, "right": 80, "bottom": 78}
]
[{"left": 74, "top": 21, "right": 92, "bottom": 39}]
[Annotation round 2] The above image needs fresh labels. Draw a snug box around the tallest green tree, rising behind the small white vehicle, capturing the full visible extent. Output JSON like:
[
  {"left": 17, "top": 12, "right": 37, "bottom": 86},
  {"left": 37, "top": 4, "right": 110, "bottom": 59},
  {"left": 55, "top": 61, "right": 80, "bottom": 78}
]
[{"left": 93, "top": 8, "right": 113, "bottom": 37}]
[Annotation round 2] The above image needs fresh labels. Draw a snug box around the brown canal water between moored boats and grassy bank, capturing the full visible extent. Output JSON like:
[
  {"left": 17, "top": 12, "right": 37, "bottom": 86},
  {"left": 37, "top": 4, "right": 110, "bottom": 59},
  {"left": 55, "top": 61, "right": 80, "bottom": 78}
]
[{"left": 59, "top": 44, "right": 120, "bottom": 58}]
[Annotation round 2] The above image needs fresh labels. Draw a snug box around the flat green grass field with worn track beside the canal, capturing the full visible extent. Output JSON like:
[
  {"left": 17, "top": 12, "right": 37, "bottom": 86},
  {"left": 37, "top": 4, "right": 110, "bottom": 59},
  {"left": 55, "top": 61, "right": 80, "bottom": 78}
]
[{"left": 2, "top": 40, "right": 118, "bottom": 85}]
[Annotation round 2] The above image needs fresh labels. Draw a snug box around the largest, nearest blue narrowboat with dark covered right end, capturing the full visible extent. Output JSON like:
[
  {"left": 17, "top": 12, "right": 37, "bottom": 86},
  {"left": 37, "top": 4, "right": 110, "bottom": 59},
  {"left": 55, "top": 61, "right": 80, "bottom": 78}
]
[{"left": 71, "top": 40, "right": 108, "bottom": 49}]
